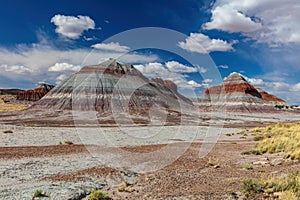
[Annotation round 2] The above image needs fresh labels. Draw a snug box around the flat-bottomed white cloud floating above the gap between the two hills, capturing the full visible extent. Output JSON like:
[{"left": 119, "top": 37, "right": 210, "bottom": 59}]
[{"left": 178, "top": 33, "right": 236, "bottom": 54}]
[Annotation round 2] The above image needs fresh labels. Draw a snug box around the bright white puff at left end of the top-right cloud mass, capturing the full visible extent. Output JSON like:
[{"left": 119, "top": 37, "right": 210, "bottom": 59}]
[{"left": 203, "top": 5, "right": 262, "bottom": 32}]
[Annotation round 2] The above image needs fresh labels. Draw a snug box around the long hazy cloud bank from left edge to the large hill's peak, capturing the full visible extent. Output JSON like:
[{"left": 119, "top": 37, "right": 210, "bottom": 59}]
[{"left": 0, "top": 44, "right": 158, "bottom": 89}]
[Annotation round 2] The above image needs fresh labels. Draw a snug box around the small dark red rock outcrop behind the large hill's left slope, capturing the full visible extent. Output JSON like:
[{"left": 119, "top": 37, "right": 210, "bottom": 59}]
[{"left": 17, "top": 83, "right": 54, "bottom": 101}]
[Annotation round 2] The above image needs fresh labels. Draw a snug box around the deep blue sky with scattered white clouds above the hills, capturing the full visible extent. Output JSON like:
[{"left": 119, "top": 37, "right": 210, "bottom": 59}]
[{"left": 0, "top": 0, "right": 300, "bottom": 104}]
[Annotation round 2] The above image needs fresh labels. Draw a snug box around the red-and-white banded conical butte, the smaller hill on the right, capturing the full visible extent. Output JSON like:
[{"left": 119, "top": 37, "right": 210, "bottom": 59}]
[{"left": 195, "top": 73, "right": 288, "bottom": 113}]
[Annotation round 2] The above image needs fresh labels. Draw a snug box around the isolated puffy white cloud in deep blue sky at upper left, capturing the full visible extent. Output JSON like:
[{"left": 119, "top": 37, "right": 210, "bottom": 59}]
[{"left": 51, "top": 15, "right": 95, "bottom": 39}]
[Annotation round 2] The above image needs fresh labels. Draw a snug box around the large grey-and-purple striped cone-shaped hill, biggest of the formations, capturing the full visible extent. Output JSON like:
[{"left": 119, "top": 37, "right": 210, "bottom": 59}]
[{"left": 33, "top": 59, "right": 192, "bottom": 113}]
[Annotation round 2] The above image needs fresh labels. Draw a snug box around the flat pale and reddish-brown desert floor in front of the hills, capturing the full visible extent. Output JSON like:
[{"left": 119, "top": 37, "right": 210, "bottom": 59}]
[{"left": 0, "top": 124, "right": 300, "bottom": 199}]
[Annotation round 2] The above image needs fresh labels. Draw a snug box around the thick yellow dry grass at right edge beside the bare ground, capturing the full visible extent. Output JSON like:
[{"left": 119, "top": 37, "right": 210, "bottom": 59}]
[{"left": 251, "top": 123, "right": 300, "bottom": 160}]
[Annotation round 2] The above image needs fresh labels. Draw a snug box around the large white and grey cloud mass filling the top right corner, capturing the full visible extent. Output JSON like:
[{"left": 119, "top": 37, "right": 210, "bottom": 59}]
[{"left": 203, "top": 0, "right": 300, "bottom": 44}]
